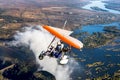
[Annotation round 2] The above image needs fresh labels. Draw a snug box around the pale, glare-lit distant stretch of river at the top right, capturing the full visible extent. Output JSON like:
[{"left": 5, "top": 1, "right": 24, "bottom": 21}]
[{"left": 82, "top": 0, "right": 120, "bottom": 14}]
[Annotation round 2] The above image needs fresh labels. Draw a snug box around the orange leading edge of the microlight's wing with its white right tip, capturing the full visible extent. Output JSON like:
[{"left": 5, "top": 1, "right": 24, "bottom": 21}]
[{"left": 43, "top": 25, "right": 83, "bottom": 49}]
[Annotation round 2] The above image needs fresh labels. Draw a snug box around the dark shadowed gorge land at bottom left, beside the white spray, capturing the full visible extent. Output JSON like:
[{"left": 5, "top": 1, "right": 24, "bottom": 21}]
[{"left": 0, "top": 47, "right": 56, "bottom": 80}]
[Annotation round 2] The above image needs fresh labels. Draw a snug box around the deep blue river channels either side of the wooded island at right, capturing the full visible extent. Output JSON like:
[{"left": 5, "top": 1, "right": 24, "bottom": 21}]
[{"left": 73, "top": 22, "right": 120, "bottom": 80}]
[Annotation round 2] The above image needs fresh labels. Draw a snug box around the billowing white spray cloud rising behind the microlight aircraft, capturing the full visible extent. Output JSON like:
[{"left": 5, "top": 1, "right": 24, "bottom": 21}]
[{"left": 11, "top": 26, "right": 77, "bottom": 80}]
